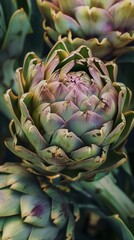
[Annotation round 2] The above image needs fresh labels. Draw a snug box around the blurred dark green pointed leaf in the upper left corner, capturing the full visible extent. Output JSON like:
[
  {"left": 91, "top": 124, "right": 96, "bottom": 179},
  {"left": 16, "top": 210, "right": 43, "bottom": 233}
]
[{"left": 0, "top": 0, "right": 31, "bottom": 65}]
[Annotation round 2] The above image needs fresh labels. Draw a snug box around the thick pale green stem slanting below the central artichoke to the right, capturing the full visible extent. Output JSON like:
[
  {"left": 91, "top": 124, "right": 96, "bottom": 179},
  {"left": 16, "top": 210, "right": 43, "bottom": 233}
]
[{"left": 72, "top": 174, "right": 134, "bottom": 233}]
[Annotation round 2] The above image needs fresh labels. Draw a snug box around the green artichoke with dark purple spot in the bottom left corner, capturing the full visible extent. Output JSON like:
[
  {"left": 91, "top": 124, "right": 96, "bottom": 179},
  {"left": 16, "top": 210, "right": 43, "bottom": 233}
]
[{"left": 0, "top": 163, "right": 79, "bottom": 240}]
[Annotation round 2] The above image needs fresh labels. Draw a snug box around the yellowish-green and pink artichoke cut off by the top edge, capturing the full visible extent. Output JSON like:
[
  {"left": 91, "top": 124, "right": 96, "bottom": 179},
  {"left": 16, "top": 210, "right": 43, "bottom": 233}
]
[{"left": 37, "top": 0, "right": 134, "bottom": 59}]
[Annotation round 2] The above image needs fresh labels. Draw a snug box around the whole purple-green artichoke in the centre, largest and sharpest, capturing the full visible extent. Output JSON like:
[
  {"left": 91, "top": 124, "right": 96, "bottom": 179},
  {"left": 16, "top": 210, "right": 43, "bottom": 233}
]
[{"left": 5, "top": 41, "right": 134, "bottom": 181}]
